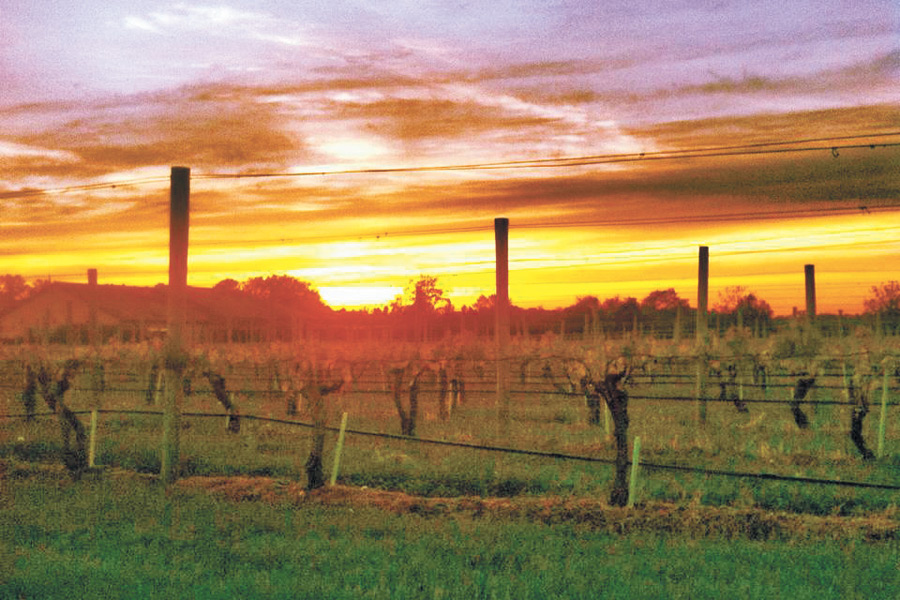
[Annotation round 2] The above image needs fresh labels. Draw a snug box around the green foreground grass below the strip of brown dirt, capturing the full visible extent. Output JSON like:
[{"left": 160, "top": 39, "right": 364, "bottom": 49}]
[{"left": 0, "top": 476, "right": 900, "bottom": 600}]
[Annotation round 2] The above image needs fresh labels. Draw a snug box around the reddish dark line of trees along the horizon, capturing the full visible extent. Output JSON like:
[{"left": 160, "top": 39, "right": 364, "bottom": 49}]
[{"left": 0, "top": 274, "right": 900, "bottom": 338}]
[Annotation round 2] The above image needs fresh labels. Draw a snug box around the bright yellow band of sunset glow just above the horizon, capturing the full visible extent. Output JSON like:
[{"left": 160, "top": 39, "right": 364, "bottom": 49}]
[{"left": 7, "top": 203, "right": 900, "bottom": 315}]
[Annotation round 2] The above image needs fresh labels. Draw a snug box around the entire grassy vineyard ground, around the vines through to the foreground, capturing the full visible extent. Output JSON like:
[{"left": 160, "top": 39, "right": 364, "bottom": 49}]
[{"left": 0, "top": 340, "right": 900, "bottom": 600}]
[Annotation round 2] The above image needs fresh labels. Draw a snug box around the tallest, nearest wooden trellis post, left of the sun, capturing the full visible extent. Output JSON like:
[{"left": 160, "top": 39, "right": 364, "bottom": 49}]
[{"left": 160, "top": 167, "right": 191, "bottom": 483}]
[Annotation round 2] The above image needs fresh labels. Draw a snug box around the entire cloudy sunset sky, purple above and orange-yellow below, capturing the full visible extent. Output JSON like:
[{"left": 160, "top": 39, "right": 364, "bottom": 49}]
[{"left": 0, "top": 0, "right": 900, "bottom": 314}]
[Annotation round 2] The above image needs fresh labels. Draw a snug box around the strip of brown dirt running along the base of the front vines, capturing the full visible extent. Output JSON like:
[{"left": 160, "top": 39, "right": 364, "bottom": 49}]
[{"left": 177, "top": 477, "right": 900, "bottom": 542}]
